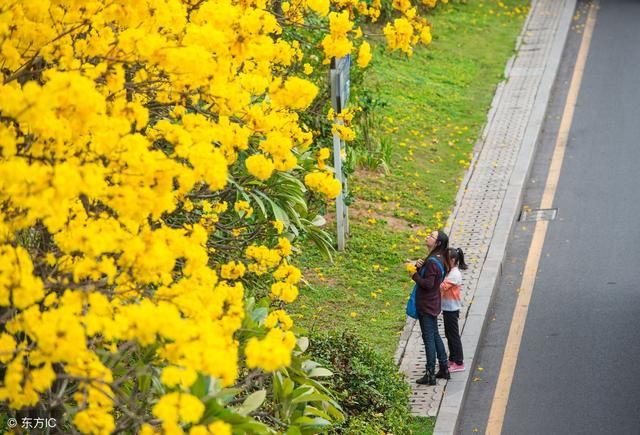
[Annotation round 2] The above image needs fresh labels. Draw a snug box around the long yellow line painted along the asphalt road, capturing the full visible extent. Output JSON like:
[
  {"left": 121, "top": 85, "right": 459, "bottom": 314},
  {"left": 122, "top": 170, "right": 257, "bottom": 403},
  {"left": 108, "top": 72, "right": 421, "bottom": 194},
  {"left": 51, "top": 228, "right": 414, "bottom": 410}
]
[{"left": 486, "top": 3, "right": 596, "bottom": 435}]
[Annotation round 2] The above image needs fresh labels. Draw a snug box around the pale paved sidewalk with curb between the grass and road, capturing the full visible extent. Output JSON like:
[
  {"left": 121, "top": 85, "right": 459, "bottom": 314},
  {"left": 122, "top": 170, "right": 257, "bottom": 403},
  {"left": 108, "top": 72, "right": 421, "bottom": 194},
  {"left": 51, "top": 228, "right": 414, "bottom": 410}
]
[{"left": 396, "top": 0, "right": 576, "bottom": 434}]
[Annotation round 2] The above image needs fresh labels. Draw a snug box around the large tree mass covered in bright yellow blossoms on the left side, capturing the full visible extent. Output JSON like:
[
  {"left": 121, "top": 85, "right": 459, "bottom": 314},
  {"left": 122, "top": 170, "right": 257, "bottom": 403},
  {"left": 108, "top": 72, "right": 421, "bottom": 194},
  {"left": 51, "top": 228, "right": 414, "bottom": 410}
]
[{"left": 0, "top": 0, "right": 450, "bottom": 434}]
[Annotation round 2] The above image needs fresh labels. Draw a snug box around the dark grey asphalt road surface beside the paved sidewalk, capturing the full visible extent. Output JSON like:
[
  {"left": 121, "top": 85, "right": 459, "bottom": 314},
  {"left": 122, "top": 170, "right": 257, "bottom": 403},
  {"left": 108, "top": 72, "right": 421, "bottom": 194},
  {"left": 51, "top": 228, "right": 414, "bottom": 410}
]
[{"left": 460, "top": 0, "right": 640, "bottom": 434}]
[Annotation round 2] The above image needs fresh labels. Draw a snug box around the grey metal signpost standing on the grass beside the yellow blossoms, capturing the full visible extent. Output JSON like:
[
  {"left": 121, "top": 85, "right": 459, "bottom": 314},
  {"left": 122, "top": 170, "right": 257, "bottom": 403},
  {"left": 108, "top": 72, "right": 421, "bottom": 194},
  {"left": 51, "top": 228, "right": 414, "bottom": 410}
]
[{"left": 330, "top": 54, "right": 351, "bottom": 251}]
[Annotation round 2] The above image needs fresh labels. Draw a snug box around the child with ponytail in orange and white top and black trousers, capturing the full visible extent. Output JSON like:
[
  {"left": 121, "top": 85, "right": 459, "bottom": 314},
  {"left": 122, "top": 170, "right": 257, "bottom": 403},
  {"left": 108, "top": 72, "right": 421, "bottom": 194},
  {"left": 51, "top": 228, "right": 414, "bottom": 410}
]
[{"left": 440, "top": 248, "right": 468, "bottom": 373}]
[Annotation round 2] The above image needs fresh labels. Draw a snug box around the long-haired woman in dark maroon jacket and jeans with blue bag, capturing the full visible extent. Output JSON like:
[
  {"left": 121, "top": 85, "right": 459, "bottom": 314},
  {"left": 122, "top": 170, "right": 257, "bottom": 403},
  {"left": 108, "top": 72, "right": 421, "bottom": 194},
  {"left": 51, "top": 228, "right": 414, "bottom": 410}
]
[{"left": 411, "top": 231, "right": 450, "bottom": 385}]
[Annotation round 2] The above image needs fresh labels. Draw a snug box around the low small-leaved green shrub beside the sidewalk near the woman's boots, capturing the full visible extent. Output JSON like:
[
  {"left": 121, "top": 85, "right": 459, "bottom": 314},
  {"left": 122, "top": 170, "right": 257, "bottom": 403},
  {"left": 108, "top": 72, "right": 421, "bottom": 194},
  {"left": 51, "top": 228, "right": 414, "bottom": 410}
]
[{"left": 308, "top": 332, "right": 411, "bottom": 434}]
